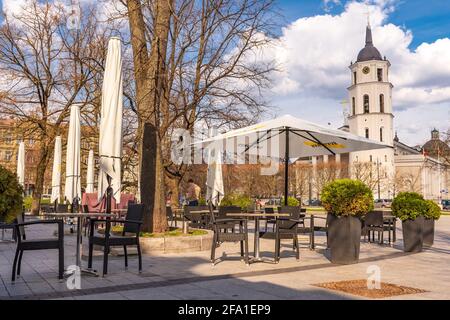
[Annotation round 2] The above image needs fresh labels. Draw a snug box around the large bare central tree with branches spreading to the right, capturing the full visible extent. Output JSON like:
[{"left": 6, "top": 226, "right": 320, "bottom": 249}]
[{"left": 124, "top": 0, "right": 274, "bottom": 231}]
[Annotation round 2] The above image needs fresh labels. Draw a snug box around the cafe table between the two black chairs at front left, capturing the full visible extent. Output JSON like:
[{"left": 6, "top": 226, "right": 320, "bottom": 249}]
[{"left": 42, "top": 212, "right": 116, "bottom": 277}]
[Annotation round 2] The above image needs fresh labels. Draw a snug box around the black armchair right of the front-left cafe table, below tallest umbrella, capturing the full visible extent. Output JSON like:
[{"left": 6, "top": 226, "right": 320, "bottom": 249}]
[{"left": 88, "top": 204, "right": 144, "bottom": 275}]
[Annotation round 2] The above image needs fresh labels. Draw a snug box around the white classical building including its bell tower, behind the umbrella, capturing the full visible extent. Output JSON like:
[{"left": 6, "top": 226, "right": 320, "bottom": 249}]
[{"left": 299, "top": 25, "right": 450, "bottom": 200}]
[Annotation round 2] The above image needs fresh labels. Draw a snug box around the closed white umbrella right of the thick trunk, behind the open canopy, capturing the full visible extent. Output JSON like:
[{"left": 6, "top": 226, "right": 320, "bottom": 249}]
[{"left": 206, "top": 129, "right": 225, "bottom": 206}]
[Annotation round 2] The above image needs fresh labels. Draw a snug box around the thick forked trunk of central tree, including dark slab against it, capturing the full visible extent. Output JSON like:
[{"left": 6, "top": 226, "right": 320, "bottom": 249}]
[{"left": 127, "top": 0, "right": 173, "bottom": 232}]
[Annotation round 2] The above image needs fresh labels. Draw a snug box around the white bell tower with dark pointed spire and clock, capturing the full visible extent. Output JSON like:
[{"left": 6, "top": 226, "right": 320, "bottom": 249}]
[{"left": 348, "top": 24, "right": 395, "bottom": 199}]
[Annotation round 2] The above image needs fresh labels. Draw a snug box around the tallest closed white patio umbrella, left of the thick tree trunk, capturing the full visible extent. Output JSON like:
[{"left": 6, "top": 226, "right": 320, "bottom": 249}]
[{"left": 98, "top": 37, "right": 123, "bottom": 203}]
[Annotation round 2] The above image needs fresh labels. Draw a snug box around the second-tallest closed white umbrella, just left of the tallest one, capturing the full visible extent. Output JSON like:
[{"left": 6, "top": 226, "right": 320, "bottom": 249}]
[{"left": 64, "top": 104, "right": 81, "bottom": 203}]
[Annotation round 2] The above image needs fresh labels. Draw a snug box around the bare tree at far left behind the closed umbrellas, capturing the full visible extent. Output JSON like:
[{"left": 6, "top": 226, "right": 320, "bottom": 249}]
[{"left": 0, "top": 0, "right": 106, "bottom": 214}]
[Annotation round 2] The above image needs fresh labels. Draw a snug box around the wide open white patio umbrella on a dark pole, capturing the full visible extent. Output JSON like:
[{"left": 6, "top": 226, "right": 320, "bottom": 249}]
[{"left": 193, "top": 115, "right": 392, "bottom": 205}]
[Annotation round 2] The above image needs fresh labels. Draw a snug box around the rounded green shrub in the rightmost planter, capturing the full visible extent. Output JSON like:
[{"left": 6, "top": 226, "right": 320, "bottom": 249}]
[{"left": 391, "top": 192, "right": 429, "bottom": 221}]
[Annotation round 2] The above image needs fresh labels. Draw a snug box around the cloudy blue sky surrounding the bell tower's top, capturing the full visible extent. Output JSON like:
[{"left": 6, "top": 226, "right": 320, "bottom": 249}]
[{"left": 0, "top": 0, "right": 450, "bottom": 146}]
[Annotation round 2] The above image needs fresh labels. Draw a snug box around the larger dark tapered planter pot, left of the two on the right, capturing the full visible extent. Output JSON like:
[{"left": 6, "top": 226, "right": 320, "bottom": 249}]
[{"left": 328, "top": 215, "right": 361, "bottom": 264}]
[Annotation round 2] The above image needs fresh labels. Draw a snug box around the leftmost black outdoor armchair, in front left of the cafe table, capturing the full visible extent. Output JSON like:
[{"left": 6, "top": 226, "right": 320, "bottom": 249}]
[{"left": 11, "top": 215, "right": 64, "bottom": 281}]
